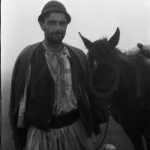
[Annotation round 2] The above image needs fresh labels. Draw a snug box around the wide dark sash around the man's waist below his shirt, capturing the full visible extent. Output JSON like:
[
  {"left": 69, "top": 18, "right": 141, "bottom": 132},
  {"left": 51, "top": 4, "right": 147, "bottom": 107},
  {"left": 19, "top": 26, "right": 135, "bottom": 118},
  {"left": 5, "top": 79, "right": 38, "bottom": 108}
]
[{"left": 50, "top": 109, "right": 80, "bottom": 129}]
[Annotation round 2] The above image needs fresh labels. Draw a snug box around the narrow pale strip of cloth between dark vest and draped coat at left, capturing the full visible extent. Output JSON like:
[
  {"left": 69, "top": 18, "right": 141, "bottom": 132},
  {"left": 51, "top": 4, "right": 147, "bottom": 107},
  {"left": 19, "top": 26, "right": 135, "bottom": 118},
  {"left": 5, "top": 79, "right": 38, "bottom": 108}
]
[{"left": 17, "top": 65, "right": 31, "bottom": 128}]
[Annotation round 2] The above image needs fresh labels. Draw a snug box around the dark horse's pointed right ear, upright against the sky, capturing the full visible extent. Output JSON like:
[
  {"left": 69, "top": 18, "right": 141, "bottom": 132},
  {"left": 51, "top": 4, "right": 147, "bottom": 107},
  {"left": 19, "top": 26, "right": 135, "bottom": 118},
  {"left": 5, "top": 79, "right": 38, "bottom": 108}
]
[{"left": 109, "top": 28, "right": 120, "bottom": 48}]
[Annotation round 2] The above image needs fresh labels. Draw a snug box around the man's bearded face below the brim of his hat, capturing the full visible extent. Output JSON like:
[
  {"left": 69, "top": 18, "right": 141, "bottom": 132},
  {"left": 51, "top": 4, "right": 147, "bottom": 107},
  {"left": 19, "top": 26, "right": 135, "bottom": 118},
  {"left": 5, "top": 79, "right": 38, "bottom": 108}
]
[{"left": 41, "top": 12, "right": 67, "bottom": 44}]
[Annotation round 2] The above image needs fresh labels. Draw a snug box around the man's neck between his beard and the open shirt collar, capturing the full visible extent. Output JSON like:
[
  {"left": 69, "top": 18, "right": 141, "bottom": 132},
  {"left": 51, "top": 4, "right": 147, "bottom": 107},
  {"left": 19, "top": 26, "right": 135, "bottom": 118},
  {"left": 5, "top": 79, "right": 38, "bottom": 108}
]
[{"left": 44, "top": 39, "right": 63, "bottom": 53}]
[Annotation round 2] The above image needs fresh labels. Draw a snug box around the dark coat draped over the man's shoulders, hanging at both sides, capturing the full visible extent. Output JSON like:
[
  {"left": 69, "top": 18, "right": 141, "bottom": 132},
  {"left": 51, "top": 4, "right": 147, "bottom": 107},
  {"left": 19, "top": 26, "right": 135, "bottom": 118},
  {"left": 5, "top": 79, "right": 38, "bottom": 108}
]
[{"left": 9, "top": 43, "right": 101, "bottom": 149}]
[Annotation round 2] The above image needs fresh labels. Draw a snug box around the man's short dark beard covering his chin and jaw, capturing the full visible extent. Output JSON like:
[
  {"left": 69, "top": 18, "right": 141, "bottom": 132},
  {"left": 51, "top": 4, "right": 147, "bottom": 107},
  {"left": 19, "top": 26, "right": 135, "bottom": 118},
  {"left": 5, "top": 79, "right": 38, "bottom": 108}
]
[{"left": 45, "top": 31, "right": 65, "bottom": 44}]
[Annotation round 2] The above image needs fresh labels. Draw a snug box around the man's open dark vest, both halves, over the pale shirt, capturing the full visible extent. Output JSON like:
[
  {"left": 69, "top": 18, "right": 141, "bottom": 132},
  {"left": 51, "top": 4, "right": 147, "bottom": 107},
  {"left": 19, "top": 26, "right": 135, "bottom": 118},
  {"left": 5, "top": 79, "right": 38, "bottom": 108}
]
[{"left": 26, "top": 44, "right": 92, "bottom": 132}]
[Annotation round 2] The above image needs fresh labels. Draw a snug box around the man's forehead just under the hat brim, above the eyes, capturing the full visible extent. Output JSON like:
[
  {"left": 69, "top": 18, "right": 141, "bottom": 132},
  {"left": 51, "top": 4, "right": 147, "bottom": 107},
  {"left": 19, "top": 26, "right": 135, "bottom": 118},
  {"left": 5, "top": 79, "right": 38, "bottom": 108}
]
[{"left": 45, "top": 12, "right": 67, "bottom": 21}]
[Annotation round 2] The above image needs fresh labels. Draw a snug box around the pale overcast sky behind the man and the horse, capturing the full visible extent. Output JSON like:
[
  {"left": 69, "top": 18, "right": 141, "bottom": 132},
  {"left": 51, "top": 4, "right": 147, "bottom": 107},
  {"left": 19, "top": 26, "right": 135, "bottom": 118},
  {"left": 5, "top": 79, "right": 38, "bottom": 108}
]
[{"left": 2, "top": 0, "right": 150, "bottom": 75}]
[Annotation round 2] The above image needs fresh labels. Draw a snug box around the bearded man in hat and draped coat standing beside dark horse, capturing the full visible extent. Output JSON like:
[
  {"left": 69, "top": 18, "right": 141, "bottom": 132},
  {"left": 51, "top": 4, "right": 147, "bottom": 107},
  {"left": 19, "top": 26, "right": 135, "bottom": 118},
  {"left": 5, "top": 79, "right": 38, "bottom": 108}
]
[{"left": 9, "top": 1, "right": 101, "bottom": 150}]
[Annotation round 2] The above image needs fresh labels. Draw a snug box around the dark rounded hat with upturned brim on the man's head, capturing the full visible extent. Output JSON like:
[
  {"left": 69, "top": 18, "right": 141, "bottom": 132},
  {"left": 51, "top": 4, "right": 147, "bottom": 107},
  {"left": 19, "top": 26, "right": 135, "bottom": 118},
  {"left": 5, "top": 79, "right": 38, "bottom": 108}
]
[{"left": 38, "top": 0, "right": 71, "bottom": 23}]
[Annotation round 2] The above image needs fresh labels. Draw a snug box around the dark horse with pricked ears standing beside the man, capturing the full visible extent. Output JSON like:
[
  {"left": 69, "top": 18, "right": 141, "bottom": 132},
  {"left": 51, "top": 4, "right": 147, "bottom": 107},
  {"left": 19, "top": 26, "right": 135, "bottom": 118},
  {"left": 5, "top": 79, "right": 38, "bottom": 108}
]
[{"left": 80, "top": 28, "right": 150, "bottom": 150}]
